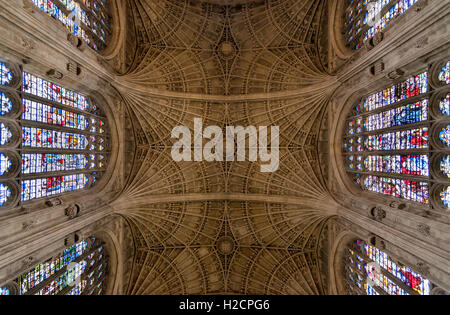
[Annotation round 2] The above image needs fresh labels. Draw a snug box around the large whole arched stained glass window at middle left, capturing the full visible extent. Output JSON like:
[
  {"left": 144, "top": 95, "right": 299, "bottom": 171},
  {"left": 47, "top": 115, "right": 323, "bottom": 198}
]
[{"left": 0, "top": 63, "right": 109, "bottom": 207}]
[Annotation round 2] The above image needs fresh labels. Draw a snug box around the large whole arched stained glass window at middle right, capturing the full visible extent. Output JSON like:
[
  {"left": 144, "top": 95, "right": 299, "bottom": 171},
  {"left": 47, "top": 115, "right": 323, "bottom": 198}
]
[{"left": 343, "top": 61, "right": 450, "bottom": 210}]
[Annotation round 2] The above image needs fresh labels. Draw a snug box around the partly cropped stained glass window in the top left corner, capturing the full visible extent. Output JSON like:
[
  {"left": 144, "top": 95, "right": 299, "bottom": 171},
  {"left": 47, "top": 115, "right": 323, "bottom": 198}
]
[{"left": 33, "top": 0, "right": 111, "bottom": 50}]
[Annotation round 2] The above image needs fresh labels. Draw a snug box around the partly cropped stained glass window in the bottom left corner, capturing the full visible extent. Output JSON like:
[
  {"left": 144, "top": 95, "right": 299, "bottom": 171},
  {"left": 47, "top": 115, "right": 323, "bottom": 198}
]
[{"left": 8, "top": 237, "right": 108, "bottom": 295}]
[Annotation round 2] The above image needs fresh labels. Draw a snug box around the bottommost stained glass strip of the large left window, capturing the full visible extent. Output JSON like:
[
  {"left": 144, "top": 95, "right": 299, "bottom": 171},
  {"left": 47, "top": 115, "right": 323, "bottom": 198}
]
[{"left": 21, "top": 174, "right": 89, "bottom": 201}]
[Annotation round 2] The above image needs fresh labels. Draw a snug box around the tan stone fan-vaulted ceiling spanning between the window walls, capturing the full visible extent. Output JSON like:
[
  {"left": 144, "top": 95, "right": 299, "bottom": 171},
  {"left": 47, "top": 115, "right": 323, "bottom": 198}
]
[{"left": 114, "top": 0, "right": 336, "bottom": 294}]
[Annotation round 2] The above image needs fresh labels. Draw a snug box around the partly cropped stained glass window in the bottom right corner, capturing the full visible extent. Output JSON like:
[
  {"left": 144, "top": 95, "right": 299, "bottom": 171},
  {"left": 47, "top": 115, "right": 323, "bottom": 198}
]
[{"left": 345, "top": 240, "right": 432, "bottom": 295}]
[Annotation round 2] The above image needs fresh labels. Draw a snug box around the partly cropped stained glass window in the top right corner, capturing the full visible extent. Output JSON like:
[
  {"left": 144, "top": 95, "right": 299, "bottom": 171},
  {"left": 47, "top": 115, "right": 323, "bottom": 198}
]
[{"left": 344, "top": 0, "right": 419, "bottom": 49}]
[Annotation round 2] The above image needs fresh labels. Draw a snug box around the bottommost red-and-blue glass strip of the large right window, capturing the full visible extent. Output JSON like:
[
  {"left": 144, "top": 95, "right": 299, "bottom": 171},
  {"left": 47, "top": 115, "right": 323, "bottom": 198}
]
[{"left": 364, "top": 175, "right": 430, "bottom": 204}]
